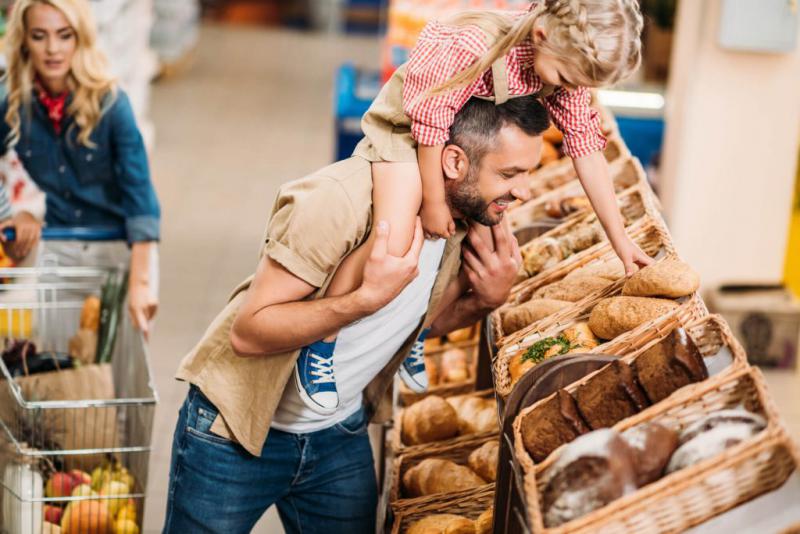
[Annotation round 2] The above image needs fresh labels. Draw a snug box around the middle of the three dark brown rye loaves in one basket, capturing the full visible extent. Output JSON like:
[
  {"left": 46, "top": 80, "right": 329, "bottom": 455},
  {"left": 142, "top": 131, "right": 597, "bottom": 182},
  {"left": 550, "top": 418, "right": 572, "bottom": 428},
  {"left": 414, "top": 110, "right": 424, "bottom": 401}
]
[{"left": 574, "top": 360, "right": 650, "bottom": 429}]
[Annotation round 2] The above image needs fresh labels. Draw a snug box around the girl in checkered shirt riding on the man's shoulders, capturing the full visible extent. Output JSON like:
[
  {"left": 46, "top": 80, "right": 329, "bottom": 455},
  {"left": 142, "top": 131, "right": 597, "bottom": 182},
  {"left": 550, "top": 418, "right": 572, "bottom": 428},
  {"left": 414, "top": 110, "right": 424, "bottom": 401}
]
[{"left": 296, "top": 0, "right": 652, "bottom": 413}]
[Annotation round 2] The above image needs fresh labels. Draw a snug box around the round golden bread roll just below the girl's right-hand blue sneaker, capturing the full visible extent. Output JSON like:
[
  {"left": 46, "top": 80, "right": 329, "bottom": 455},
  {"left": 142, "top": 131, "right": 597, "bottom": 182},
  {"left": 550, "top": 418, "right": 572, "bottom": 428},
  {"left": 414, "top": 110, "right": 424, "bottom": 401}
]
[{"left": 402, "top": 395, "right": 458, "bottom": 445}]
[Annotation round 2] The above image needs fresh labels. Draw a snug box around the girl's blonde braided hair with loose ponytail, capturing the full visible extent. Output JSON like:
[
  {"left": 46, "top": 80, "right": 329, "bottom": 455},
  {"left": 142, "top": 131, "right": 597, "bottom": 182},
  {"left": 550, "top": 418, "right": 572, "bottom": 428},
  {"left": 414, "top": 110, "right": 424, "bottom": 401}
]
[{"left": 432, "top": 0, "right": 643, "bottom": 94}]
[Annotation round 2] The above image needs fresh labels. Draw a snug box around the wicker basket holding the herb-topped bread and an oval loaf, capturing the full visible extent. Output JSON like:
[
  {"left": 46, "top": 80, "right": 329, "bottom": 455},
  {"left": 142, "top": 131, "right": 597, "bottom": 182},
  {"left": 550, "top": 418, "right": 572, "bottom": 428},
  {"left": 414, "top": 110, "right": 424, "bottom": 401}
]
[{"left": 494, "top": 292, "right": 708, "bottom": 398}]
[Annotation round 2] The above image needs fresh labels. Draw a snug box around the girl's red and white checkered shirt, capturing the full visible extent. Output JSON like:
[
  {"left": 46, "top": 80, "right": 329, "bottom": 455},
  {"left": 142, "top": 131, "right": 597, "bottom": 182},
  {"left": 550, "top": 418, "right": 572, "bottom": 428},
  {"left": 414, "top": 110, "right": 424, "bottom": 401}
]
[{"left": 403, "top": 11, "right": 606, "bottom": 158}]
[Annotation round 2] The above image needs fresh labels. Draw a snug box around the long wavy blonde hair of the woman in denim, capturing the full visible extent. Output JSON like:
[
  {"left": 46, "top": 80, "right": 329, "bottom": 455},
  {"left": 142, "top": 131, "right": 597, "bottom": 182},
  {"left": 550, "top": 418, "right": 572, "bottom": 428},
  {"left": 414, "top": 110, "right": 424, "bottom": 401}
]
[{"left": 4, "top": 0, "right": 116, "bottom": 147}]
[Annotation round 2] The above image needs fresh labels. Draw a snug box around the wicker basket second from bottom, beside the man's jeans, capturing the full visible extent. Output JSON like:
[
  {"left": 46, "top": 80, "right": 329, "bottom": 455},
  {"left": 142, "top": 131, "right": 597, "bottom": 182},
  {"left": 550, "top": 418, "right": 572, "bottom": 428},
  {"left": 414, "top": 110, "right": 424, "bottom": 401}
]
[{"left": 389, "top": 437, "right": 498, "bottom": 513}]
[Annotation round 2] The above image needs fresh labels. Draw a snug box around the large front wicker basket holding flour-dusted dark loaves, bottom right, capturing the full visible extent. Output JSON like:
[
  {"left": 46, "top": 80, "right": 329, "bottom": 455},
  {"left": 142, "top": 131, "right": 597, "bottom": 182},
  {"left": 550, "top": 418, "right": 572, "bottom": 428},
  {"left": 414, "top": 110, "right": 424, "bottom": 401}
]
[{"left": 514, "top": 367, "right": 797, "bottom": 534}]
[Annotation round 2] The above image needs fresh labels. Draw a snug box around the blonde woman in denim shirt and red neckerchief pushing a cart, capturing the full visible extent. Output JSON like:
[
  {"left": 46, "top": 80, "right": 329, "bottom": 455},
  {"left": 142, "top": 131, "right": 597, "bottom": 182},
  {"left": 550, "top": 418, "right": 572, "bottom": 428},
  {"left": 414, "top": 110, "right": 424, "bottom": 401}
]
[{"left": 0, "top": 0, "right": 160, "bottom": 335}]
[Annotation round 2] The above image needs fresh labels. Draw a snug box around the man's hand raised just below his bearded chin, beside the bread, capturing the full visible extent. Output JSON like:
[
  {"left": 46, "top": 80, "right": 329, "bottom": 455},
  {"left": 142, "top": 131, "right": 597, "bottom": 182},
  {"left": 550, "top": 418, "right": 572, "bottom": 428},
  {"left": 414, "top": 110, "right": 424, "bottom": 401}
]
[{"left": 464, "top": 221, "right": 522, "bottom": 309}]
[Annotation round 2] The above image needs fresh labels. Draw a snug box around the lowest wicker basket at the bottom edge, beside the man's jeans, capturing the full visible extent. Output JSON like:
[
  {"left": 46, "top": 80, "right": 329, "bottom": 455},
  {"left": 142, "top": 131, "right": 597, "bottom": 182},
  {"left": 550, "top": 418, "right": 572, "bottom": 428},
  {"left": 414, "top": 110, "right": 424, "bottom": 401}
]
[{"left": 392, "top": 484, "right": 494, "bottom": 534}]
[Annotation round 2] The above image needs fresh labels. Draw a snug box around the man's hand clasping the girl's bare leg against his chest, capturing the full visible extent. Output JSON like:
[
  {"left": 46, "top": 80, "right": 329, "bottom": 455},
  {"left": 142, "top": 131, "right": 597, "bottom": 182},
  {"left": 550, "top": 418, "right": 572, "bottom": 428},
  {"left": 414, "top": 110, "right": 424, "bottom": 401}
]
[{"left": 356, "top": 217, "right": 424, "bottom": 312}]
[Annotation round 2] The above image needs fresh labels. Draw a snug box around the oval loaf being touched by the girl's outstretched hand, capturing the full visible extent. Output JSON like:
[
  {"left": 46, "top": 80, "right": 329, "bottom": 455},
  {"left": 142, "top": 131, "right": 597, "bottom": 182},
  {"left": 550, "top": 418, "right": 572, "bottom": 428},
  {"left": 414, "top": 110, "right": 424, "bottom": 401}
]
[{"left": 622, "top": 258, "right": 700, "bottom": 298}]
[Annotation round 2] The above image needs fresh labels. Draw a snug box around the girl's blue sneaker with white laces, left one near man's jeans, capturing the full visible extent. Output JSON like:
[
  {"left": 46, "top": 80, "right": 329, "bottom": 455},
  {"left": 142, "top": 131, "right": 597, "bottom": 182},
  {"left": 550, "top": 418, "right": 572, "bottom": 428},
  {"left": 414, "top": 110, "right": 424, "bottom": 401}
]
[{"left": 294, "top": 341, "right": 339, "bottom": 415}]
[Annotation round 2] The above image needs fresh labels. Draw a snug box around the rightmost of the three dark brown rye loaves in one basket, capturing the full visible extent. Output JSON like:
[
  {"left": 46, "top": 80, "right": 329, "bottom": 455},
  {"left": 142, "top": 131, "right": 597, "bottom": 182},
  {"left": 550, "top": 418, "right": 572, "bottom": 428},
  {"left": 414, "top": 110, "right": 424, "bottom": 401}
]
[{"left": 633, "top": 328, "right": 708, "bottom": 404}]
